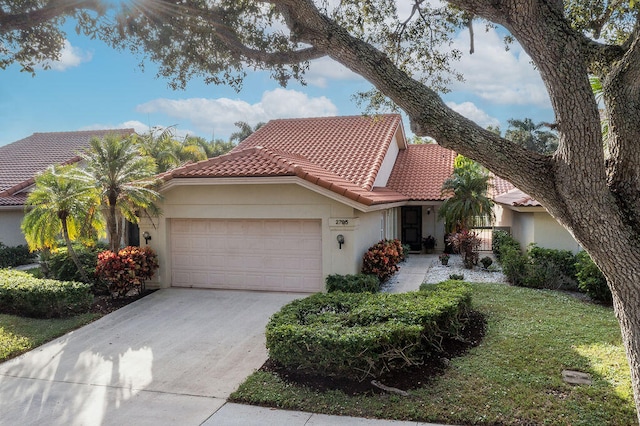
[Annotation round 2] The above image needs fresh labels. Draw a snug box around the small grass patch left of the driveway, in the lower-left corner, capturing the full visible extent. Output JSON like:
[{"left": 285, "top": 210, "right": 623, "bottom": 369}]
[{"left": 0, "top": 313, "right": 101, "bottom": 362}]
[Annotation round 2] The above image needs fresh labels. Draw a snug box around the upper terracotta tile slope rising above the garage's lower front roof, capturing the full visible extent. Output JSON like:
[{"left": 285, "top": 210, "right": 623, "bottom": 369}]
[{"left": 234, "top": 114, "right": 402, "bottom": 190}]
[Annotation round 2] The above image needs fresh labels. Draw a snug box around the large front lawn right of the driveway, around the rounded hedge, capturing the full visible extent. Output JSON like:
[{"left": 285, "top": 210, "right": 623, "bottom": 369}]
[{"left": 231, "top": 283, "right": 637, "bottom": 425}]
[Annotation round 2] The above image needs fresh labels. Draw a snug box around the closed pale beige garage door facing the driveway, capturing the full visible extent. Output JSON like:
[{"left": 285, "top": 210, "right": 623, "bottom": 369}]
[{"left": 171, "top": 219, "right": 324, "bottom": 292}]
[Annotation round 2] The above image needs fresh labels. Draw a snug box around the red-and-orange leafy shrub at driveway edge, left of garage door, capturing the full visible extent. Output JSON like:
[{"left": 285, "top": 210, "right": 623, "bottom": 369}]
[{"left": 96, "top": 246, "right": 158, "bottom": 297}]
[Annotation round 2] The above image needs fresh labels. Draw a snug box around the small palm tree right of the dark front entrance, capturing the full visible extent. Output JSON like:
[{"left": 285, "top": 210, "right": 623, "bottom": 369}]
[{"left": 438, "top": 156, "right": 494, "bottom": 232}]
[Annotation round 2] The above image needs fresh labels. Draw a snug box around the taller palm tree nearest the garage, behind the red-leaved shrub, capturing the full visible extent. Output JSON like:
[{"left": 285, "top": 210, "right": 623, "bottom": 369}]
[{"left": 81, "top": 135, "right": 160, "bottom": 252}]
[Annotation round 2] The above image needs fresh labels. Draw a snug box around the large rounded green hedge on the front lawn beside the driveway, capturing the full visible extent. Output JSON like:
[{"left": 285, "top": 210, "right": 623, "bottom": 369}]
[{"left": 266, "top": 281, "right": 471, "bottom": 379}]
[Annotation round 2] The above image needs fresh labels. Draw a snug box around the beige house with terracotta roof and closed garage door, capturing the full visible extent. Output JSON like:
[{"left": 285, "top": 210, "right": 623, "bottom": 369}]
[{"left": 140, "top": 114, "right": 455, "bottom": 292}]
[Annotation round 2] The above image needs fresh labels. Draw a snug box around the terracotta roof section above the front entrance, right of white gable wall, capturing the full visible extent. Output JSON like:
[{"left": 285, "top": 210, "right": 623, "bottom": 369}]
[{"left": 387, "top": 144, "right": 456, "bottom": 201}]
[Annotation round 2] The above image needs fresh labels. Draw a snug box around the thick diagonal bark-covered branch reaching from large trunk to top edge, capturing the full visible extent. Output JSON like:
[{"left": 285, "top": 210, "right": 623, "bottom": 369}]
[{"left": 271, "top": 0, "right": 553, "bottom": 196}]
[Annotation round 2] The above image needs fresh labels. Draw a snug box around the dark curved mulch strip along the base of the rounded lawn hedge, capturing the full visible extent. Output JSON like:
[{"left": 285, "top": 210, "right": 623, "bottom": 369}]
[{"left": 260, "top": 311, "right": 487, "bottom": 395}]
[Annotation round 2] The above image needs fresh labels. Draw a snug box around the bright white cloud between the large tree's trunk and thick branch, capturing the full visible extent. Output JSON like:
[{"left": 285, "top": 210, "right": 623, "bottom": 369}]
[{"left": 452, "top": 25, "right": 550, "bottom": 107}]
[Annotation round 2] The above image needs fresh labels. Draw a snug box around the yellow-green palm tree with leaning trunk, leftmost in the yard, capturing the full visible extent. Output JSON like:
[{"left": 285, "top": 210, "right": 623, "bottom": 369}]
[{"left": 21, "top": 166, "right": 104, "bottom": 282}]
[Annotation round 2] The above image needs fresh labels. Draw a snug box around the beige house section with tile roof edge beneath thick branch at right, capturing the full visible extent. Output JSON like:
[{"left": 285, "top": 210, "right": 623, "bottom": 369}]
[{"left": 494, "top": 185, "right": 581, "bottom": 253}]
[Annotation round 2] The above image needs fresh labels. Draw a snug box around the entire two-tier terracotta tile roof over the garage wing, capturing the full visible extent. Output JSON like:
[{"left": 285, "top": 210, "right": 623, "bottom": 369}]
[{"left": 162, "top": 114, "right": 407, "bottom": 206}]
